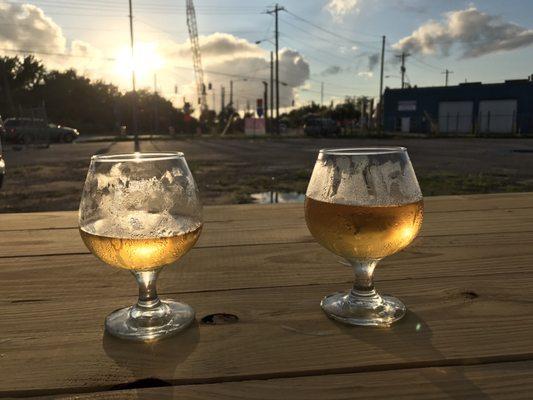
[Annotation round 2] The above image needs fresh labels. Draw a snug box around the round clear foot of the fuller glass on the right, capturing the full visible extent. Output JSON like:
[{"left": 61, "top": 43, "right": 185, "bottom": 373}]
[{"left": 320, "top": 290, "right": 406, "bottom": 327}]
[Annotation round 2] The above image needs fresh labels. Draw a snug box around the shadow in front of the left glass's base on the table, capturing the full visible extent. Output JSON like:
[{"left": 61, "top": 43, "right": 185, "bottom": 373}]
[{"left": 102, "top": 321, "right": 200, "bottom": 400}]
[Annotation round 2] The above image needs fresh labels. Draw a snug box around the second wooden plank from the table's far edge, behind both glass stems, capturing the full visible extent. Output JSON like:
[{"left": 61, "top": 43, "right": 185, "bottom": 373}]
[{"left": 0, "top": 208, "right": 533, "bottom": 257}]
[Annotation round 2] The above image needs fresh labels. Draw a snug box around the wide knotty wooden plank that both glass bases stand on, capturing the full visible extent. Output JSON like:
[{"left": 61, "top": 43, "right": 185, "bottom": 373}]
[{"left": 0, "top": 273, "right": 533, "bottom": 396}]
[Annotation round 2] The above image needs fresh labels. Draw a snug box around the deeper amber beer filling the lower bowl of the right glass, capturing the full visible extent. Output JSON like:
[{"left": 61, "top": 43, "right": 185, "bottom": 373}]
[{"left": 305, "top": 197, "right": 424, "bottom": 260}]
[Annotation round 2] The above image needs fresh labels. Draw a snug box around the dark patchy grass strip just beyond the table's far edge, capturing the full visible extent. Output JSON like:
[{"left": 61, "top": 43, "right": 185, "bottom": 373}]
[{"left": 0, "top": 161, "right": 533, "bottom": 212}]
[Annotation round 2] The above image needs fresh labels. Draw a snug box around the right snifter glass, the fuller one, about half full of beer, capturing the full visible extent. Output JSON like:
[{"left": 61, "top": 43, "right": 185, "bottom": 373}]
[{"left": 305, "top": 147, "right": 424, "bottom": 326}]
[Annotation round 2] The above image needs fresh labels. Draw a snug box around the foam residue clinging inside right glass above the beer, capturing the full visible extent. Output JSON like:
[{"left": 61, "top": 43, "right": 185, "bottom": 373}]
[{"left": 306, "top": 155, "right": 422, "bottom": 206}]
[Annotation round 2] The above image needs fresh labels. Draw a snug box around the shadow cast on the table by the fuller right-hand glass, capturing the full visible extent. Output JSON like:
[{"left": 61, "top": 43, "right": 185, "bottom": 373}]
[{"left": 333, "top": 311, "right": 488, "bottom": 400}]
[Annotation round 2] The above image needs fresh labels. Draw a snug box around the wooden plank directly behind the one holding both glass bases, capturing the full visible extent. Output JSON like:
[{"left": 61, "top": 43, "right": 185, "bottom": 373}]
[{"left": 0, "top": 232, "right": 533, "bottom": 302}]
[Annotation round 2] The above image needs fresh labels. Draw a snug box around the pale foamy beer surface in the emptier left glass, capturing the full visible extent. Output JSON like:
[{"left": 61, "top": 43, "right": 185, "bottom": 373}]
[{"left": 82, "top": 211, "right": 202, "bottom": 239}]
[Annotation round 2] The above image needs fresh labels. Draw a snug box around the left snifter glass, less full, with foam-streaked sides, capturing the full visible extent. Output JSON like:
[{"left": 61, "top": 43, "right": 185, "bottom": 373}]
[{"left": 79, "top": 152, "right": 202, "bottom": 340}]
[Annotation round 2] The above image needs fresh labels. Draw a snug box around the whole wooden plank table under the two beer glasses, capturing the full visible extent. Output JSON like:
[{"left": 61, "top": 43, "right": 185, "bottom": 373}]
[{"left": 0, "top": 193, "right": 533, "bottom": 399}]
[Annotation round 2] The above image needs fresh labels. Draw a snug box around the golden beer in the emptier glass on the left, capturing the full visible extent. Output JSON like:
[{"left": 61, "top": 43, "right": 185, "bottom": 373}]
[{"left": 80, "top": 225, "right": 202, "bottom": 271}]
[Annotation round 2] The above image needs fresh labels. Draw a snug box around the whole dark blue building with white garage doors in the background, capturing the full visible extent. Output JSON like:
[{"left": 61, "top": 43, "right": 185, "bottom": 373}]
[{"left": 383, "top": 75, "right": 533, "bottom": 135}]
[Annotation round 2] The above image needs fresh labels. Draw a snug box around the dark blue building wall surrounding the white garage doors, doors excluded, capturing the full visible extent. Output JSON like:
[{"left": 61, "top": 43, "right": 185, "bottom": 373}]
[{"left": 384, "top": 80, "right": 533, "bottom": 134}]
